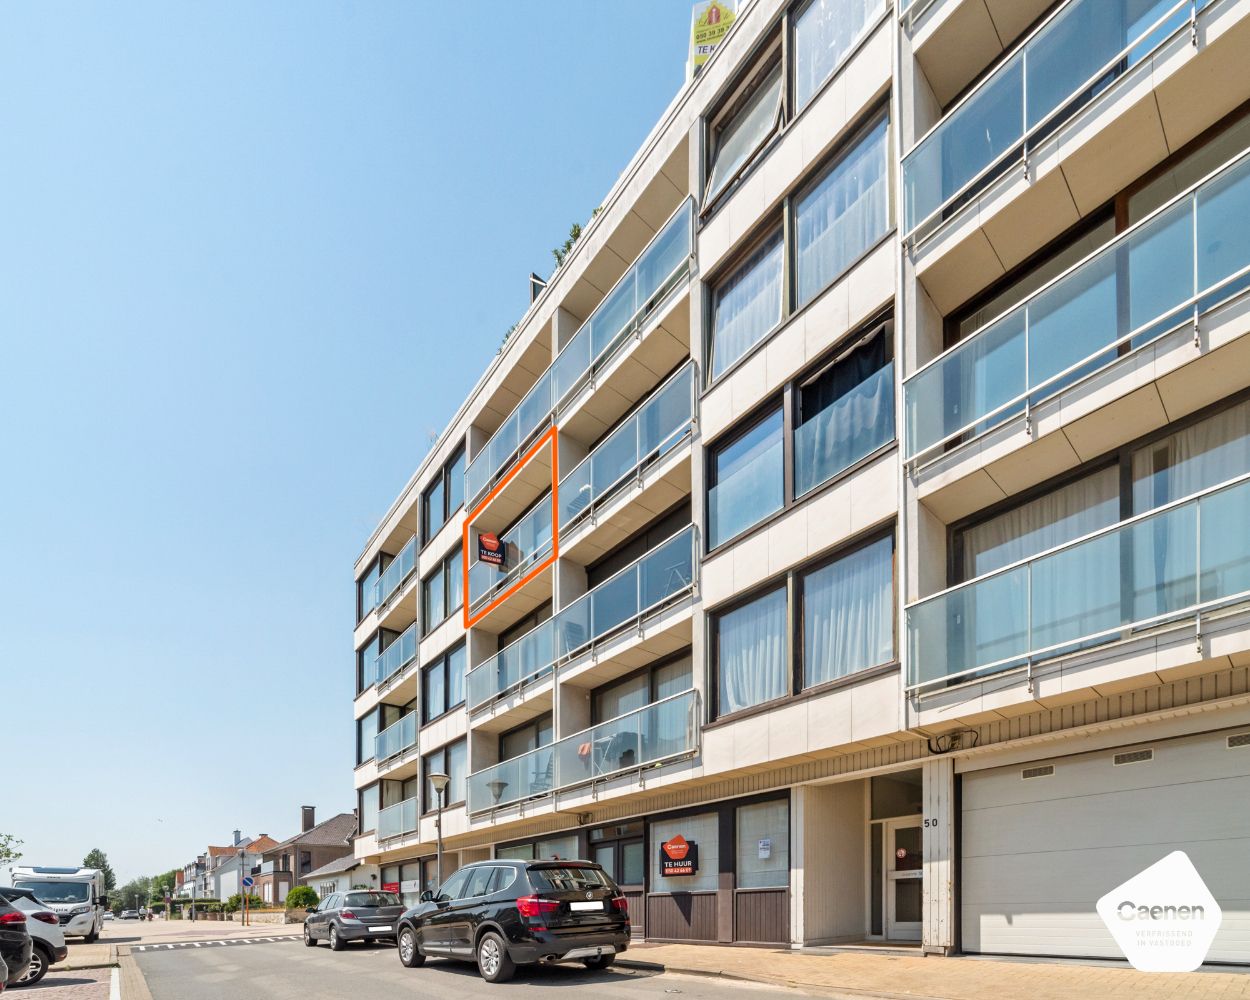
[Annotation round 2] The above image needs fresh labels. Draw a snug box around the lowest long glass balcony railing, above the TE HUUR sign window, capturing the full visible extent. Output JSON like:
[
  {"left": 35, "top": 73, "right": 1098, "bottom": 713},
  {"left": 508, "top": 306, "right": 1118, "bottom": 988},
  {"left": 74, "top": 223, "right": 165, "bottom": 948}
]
[{"left": 469, "top": 690, "right": 700, "bottom": 813}]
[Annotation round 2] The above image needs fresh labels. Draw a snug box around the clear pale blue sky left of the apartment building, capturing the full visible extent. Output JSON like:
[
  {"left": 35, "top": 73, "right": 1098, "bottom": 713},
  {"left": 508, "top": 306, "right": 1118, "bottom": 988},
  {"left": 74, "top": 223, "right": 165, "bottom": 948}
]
[{"left": 0, "top": 0, "right": 690, "bottom": 878}]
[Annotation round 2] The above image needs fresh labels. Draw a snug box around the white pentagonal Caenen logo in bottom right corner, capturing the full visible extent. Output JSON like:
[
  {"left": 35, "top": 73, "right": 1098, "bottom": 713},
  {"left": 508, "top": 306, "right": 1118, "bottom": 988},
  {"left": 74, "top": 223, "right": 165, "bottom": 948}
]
[{"left": 1098, "top": 851, "right": 1224, "bottom": 973}]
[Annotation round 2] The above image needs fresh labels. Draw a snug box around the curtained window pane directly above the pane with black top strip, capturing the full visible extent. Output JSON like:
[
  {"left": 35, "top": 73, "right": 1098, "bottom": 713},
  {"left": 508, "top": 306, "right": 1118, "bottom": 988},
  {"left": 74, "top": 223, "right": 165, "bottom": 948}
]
[{"left": 795, "top": 119, "right": 890, "bottom": 306}]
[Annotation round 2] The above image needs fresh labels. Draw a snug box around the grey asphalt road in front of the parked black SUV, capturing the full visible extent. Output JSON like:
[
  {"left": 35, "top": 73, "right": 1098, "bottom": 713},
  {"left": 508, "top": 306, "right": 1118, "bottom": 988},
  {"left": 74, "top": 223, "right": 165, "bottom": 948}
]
[{"left": 134, "top": 941, "right": 804, "bottom": 1000}]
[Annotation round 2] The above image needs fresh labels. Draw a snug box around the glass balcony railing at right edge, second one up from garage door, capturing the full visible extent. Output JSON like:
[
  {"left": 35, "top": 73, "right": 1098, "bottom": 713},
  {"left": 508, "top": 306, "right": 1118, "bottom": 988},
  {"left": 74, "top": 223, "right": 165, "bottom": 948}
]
[{"left": 904, "top": 143, "right": 1250, "bottom": 459}]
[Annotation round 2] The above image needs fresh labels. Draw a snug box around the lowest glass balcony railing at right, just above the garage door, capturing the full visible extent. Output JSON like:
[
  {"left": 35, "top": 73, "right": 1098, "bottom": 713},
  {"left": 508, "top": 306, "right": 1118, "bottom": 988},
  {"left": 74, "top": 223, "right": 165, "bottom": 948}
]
[{"left": 906, "top": 476, "right": 1250, "bottom": 690}]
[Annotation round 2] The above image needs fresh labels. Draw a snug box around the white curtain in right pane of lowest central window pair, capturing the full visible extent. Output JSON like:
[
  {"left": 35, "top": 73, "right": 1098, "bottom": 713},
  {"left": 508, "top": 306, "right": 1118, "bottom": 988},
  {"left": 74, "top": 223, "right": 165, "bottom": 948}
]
[{"left": 803, "top": 538, "right": 894, "bottom": 688}]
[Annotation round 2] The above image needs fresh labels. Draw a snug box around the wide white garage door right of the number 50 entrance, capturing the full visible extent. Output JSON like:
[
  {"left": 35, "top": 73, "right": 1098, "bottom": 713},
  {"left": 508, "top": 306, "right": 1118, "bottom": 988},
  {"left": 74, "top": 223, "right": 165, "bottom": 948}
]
[{"left": 960, "top": 730, "right": 1250, "bottom": 963}]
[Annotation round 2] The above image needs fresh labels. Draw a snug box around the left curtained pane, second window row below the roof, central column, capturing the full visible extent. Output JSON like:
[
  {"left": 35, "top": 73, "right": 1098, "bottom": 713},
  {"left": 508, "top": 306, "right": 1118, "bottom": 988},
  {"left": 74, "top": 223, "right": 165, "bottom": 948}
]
[{"left": 711, "top": 230, "right": 783, "bottom": 379}]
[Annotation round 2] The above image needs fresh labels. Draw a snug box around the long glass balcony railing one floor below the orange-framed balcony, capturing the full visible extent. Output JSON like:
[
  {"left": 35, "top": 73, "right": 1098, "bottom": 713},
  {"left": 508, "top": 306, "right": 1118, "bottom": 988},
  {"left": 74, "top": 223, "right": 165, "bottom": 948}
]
[{"left": 465, "top": 525, "right": 695, "bottom": 709}]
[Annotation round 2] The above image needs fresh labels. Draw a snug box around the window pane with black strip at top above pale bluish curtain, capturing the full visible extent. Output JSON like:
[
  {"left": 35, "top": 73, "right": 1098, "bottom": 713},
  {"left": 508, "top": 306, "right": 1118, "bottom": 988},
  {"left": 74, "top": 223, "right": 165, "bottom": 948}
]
[{"left": 794, "top": 334, "right": 894, "bottom": 496}]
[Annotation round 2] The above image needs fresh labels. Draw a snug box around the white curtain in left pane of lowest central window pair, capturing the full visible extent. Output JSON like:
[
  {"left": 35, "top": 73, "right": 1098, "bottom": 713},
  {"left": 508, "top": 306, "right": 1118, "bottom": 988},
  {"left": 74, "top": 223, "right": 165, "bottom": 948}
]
[{"left": 718, "top": 589, "right": 789, "bottom": 715}]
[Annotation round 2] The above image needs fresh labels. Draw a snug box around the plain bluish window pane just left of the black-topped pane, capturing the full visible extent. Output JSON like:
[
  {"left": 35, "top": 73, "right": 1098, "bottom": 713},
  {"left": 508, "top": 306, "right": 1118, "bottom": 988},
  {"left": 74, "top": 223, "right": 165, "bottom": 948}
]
[{"left": 708, "top": 410, "right": 785, "bottom": 546}]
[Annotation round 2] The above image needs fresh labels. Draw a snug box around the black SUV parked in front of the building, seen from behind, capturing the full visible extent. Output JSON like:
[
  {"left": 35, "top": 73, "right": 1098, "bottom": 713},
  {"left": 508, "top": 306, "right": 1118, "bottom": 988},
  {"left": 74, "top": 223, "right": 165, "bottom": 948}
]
[{"left": 399, "top": 860, "right": 630, "bottom": 983}]
